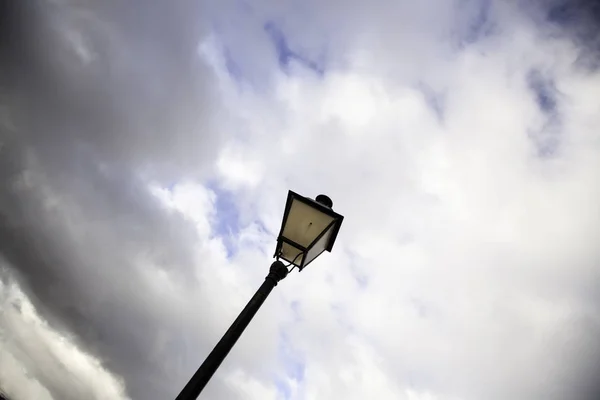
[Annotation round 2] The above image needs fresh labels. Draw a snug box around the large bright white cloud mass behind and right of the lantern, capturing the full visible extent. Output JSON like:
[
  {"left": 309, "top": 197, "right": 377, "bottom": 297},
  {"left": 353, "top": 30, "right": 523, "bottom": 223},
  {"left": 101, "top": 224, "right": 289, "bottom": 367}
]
[{"left": 185, "top": 1, "right": 600, "bottom": 398}]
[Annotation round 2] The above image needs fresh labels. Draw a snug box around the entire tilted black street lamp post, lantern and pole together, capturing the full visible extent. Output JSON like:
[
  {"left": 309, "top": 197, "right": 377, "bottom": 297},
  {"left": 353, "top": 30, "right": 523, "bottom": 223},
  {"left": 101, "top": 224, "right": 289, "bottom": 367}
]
[{"left": 175, "top": 191, "right": 344, "bottom": 400}]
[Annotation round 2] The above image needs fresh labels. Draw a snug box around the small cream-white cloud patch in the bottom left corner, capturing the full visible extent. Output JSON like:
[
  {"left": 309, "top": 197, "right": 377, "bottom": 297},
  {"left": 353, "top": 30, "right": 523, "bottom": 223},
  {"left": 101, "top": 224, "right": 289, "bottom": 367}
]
[{"left": 0, "top": 265, "right": 128, "bottom": 400}]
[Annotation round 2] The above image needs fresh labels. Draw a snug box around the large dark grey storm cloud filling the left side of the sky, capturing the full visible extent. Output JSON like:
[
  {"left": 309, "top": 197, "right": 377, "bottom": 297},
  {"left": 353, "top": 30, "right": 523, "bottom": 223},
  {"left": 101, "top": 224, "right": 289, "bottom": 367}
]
[{"left": 0, "top": 0, "right": 232, "bottom": 399}]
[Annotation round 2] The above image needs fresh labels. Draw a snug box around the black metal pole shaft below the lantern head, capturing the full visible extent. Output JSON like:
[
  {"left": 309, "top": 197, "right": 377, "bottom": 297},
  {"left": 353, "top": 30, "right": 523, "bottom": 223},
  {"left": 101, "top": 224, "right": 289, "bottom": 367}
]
[{"left": 175, "top": 261, "right": 288, "bottom": 400}]
